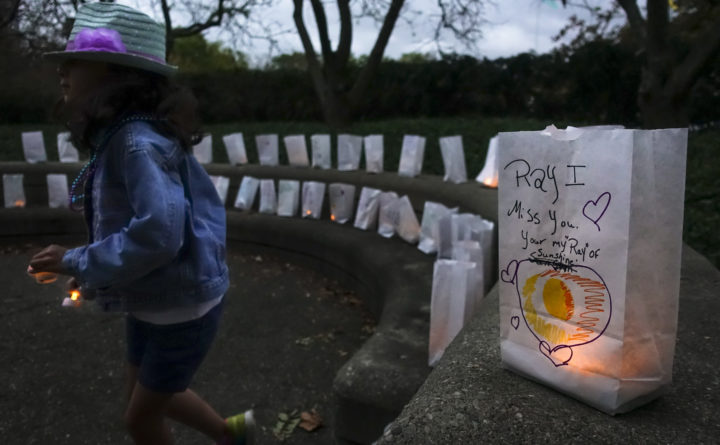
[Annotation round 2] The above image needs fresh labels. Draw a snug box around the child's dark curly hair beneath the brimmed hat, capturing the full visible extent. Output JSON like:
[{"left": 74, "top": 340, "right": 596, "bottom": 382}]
[{"left": 54, "top": 64, "right": 202, "bottom": 152}]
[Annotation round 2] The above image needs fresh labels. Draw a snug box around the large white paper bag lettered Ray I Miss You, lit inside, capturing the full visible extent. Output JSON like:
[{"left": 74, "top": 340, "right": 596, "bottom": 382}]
[{"left": 498, "top": 127, "right": 687, "bottom": 414}]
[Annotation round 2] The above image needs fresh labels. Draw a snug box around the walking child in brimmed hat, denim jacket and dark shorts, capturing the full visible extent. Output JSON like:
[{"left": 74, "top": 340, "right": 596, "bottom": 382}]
[{"left": 30, "top": 3, "right": 254, "bottom": 445}]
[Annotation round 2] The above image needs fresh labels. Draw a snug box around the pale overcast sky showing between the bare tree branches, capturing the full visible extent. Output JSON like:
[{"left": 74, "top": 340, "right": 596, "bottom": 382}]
[{"left": 124, "top": 0, "right": 620, "bottom": 63}]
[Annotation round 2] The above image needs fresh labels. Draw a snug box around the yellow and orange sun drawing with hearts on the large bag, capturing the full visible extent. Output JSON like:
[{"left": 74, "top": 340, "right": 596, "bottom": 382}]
[{"left": 501, "top": 259, "right": 612, "bottom": 367}]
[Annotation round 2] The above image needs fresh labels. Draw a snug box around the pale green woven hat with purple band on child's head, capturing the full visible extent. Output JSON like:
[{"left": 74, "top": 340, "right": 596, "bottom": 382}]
[{"left": 44, "top": 3, "right": 177, "bottom": 76}]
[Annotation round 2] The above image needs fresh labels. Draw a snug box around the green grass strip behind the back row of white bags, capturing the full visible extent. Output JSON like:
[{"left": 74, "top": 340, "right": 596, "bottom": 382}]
[{"left": 0, "top": 117, "right": 720, "bottom": 267}]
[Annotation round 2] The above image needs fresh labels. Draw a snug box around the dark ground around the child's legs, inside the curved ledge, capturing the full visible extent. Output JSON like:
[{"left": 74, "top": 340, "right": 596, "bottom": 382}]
[{"left": 0, "top": 244, "right": 374, "bottom": 445}]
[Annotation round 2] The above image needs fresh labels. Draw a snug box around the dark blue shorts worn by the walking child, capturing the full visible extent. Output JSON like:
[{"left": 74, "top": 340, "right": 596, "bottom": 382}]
[{"left": 126, "top": 301, "right": 223, "bottom": 393}]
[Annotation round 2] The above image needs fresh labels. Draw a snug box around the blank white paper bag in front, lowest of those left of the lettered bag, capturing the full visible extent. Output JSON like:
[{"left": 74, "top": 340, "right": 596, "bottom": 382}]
[{"left": 428, "top": 260, "right": 477, "bottom": 366}]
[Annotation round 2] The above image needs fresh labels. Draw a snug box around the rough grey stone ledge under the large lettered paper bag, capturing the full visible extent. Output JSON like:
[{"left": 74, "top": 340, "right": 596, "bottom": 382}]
[{"left": 378, "top": 245, "right": 720, "bottom": 445}]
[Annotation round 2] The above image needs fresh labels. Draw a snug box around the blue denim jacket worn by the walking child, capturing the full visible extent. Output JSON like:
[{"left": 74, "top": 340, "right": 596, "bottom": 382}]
[{"left": 62, "top": 121, "right": 229, "bottom": 311}]
